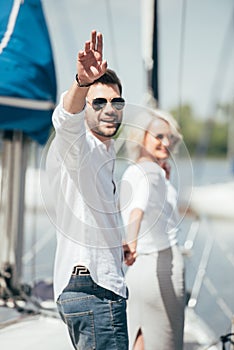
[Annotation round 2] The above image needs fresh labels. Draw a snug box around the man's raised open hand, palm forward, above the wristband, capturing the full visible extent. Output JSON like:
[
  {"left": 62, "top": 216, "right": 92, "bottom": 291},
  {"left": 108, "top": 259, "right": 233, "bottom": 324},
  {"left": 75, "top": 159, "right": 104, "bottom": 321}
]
[{"left": 77, "top": 30, "right": 107, "bottom": 85}]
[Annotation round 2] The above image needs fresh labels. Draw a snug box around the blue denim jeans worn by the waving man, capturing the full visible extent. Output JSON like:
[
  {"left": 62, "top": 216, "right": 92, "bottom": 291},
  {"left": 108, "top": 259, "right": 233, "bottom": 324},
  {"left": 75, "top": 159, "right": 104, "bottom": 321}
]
[{"left": 57, "top": 276, "right": 128, "bottom": 350}]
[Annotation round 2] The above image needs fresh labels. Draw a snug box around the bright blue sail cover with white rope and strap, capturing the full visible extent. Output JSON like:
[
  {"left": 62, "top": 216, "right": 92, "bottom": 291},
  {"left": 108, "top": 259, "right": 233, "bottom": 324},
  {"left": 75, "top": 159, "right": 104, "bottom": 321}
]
[{"left": 0, "top": 0, "right": 56, "bottom": 144}]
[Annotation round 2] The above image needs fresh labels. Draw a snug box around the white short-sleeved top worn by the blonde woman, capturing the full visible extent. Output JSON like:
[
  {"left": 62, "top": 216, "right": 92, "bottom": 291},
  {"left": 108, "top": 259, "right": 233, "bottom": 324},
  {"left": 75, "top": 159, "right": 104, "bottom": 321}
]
[{"left": 120, "top": 161, "right": 179, "bottom": 254}]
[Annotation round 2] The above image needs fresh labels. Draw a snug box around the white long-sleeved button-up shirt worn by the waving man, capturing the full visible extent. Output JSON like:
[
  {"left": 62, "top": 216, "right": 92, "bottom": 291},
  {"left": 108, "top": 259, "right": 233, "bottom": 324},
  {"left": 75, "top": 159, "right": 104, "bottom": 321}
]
[{"left": 47, "top": 96, "right": 126, "bottom": 300}]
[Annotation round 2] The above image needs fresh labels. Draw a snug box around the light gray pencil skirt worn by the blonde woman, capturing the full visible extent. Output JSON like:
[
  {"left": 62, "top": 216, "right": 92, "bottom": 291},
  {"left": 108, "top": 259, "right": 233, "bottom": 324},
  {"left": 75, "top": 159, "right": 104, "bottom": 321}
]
[{"left": 126, "top": 246, "right": 185, "bottom": 350}]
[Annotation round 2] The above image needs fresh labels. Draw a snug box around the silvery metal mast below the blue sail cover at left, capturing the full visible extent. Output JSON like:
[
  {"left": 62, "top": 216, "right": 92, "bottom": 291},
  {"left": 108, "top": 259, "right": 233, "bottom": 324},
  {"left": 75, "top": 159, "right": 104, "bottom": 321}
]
[{"left": 0, "top": 131, "right": 27, "bottom": 285}]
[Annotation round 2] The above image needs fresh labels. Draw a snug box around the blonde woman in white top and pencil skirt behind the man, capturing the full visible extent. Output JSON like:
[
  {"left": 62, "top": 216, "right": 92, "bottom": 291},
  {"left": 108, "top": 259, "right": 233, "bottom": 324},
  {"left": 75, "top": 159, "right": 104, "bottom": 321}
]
[{"left": 120, "top": 110, "right": 185, "bottom": 350}]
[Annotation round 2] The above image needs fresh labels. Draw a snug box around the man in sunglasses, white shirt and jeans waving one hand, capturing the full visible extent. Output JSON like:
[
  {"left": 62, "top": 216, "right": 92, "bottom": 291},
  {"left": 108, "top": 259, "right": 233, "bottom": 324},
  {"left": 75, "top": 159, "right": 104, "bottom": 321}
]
[{"left": 47, "top": 31, "right": 134, "bottom": 350}]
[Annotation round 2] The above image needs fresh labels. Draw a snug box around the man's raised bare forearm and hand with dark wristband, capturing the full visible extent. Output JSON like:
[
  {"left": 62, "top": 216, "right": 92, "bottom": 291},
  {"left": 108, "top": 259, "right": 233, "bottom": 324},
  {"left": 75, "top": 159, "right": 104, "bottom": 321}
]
[{"left": 63, "top": 30, "right": 107, "bottom": 114}]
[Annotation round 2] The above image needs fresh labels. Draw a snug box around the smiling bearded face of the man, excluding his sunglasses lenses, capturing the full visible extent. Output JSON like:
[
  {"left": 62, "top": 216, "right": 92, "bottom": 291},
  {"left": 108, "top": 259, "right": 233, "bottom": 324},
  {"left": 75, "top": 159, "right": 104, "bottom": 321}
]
[{"left": 85, "top": 83, "right": 123, "bottom": 141}]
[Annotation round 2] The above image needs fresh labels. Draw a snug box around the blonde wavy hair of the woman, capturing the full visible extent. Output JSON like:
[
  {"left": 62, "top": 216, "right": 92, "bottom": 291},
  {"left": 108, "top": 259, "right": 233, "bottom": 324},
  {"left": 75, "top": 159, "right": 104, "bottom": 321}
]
[{"left": 122, "top": 108, "right": 183, "bottom": 161}]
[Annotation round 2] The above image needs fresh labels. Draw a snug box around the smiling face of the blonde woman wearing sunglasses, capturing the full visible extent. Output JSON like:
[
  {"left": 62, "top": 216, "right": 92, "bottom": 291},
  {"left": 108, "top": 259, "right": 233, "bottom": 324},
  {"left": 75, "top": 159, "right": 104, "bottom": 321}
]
[{"left": 143, "top": 119, "right": 172, "bottom": 160}]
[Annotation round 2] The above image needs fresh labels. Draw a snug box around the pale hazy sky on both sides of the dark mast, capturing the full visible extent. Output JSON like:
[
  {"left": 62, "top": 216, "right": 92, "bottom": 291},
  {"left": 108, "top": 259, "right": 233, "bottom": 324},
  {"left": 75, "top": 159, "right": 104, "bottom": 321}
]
[{"left": 42, "top": 0, "right": 234, "bottom": 118}]
